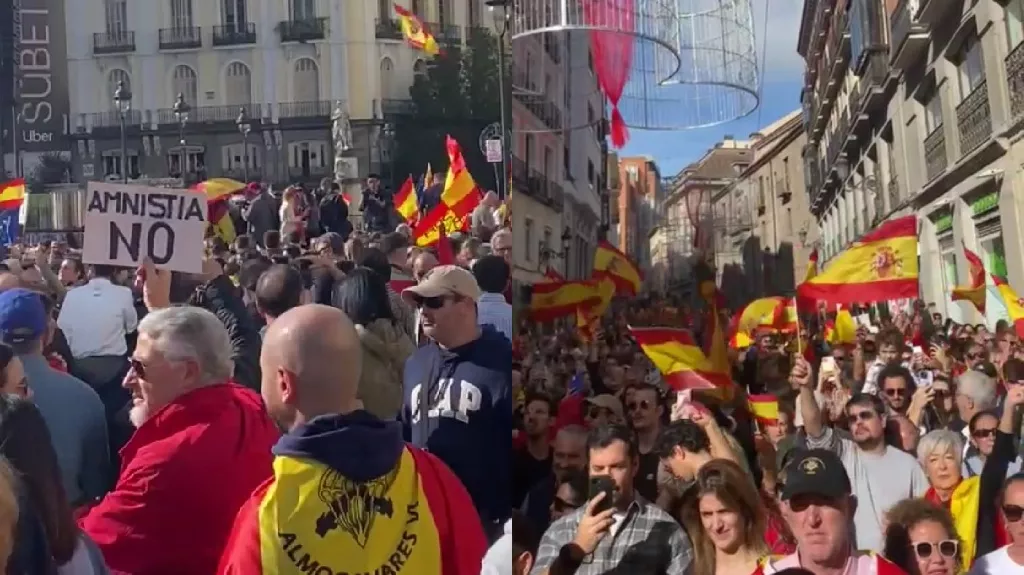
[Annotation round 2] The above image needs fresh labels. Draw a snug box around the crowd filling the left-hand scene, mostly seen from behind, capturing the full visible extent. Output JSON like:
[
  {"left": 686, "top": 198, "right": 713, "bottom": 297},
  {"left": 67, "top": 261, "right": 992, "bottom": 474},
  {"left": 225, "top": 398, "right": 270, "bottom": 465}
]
[{"left": 0, "top": 177, "right": 513, "bottom": 575}]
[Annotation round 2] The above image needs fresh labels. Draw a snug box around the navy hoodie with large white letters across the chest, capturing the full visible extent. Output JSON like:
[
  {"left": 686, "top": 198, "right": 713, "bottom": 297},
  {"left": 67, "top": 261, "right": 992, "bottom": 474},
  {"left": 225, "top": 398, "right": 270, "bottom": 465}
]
[{"left": 401, "top": 325, "right": 512, "bottom": 526}]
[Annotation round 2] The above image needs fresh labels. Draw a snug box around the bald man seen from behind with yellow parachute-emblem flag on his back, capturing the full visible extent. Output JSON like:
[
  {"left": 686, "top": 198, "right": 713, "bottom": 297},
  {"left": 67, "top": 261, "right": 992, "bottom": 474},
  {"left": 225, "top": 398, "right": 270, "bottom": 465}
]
[{"left": 218, "top": 304, "right": 486, "bottom": 575}]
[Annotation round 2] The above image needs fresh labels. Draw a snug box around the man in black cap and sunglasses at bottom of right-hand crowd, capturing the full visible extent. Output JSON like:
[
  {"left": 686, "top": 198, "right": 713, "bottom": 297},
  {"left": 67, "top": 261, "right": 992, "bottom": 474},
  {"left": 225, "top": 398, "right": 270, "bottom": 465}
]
[{"left": 754, "top": 449, "right": 905, "bottom": 575}]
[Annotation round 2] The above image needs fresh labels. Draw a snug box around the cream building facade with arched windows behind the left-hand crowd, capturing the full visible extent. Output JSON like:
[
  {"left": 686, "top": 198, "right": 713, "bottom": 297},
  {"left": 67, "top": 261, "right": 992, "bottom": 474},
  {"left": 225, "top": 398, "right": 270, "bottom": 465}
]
[{"left": 65, "top": 0, "right": 485, "bottom": 184}]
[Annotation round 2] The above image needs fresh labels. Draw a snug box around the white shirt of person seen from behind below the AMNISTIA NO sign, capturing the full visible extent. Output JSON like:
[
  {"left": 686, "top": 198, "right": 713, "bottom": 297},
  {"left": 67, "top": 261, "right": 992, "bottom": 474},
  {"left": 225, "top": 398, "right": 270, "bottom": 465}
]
[{"left": 57, "top": 277, "right": 138, "bottom": 359}]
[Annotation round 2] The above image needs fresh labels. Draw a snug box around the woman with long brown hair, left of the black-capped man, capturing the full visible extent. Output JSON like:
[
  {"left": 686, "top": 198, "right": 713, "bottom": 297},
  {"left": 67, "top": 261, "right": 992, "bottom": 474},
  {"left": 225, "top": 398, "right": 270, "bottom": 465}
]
[{"left": 682, "top": 459, "right": 769, "bottom": 575}]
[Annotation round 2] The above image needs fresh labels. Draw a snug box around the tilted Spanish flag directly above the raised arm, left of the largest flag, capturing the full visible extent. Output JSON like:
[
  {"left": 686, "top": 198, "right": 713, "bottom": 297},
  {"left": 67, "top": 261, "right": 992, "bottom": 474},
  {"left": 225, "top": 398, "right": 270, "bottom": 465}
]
[{"left": 630, "top": 327, "right": 732, "bottom": 391}]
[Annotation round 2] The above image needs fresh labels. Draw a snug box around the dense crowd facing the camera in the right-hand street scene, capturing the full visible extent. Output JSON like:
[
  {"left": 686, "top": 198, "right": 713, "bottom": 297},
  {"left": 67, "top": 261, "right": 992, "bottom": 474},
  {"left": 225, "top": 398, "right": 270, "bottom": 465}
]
[{"left": 509, "top": 297, "right": 1024, "bottom": 575}]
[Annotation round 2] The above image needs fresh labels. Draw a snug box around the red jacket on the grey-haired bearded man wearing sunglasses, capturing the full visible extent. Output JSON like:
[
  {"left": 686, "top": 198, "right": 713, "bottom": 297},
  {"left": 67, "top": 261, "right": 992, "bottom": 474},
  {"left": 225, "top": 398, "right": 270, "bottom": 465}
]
[{"left": 79, "top": 384, "right": 279, "bottom": 575}]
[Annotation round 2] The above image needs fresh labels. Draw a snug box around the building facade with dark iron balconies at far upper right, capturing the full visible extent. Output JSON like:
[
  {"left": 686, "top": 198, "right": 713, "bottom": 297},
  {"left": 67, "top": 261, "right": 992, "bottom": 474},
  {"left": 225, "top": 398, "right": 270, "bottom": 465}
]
[{"left": 798, "top": 0, "right": 1024, "bottom": 323}]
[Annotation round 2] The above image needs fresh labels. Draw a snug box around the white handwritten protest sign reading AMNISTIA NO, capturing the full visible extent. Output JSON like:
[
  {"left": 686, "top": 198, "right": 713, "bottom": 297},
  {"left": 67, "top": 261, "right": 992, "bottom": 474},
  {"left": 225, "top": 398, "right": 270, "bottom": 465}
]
[{"left": 82, "top": 182, "right": 207, "bottom": 273}]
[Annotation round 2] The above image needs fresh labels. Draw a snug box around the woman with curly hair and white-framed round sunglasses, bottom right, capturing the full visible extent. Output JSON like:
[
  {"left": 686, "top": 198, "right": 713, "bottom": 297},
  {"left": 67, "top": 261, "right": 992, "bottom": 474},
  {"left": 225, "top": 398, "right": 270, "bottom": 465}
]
[{"left": 884, "top": 499, "right": 964, "bottom": 575}]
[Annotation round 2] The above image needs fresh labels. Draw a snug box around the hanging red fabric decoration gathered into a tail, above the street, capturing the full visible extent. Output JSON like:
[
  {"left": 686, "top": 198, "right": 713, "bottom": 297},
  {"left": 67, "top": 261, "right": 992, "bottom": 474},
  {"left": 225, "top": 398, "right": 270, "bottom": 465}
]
[{"left": 583, "top": 0, "right": 636, "bottom": 147}]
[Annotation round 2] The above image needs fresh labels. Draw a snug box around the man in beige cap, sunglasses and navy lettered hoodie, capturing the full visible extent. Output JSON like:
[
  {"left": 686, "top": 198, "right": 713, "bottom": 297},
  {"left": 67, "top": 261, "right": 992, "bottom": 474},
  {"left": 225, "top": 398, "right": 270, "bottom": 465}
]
[{"left": 401, "top": 265, "right": 512, "bottom": 538}]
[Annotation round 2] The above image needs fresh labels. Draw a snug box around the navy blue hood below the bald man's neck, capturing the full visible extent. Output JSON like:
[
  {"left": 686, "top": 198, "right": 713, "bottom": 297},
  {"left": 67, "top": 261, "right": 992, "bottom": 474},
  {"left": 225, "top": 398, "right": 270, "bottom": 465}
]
[{"left": 273, "top": 411, "right": 406, "bottom": 482}]
